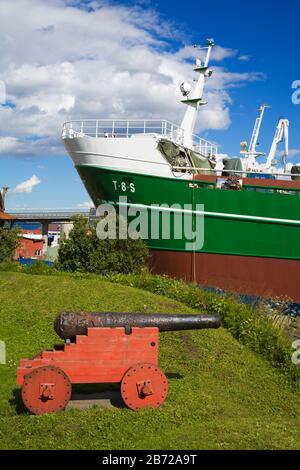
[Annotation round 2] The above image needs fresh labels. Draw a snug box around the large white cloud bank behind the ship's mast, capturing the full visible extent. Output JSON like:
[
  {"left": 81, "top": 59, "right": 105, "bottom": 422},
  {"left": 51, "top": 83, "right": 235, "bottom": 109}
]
[{"left": 0, "top": 0, "right": 263, "bottom": 157}]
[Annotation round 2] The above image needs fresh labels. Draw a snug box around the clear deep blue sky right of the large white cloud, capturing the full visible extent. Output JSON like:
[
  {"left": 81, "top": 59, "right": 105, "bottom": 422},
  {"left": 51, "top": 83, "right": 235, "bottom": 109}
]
[{"left": 156, "top": 0, "right": 300, "bottom": 155}]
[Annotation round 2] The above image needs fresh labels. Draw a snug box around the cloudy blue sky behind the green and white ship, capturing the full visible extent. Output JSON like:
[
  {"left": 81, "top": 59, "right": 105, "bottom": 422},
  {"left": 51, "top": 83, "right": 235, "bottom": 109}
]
[{"left": 0, "top": 0, "right": 300, "bottom": 208}]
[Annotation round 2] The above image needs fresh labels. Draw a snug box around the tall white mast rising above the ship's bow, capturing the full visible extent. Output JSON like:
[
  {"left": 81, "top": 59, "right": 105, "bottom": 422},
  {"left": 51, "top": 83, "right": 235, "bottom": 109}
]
[{"left": 180, "top": 39, "right": 214, "bottom": 147}]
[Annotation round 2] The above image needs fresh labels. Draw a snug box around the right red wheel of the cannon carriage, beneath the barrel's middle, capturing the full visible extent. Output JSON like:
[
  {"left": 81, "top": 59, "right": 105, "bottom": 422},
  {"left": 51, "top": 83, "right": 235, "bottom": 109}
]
[{"left": 121, "top": 364, "right": 168, "bottom": 411}]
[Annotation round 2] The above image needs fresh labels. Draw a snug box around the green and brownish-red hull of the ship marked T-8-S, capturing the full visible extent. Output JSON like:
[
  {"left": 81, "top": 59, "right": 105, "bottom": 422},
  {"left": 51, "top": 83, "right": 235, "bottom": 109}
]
[{"left": 77, "top": 165, "right": 300, "bottom": 300}]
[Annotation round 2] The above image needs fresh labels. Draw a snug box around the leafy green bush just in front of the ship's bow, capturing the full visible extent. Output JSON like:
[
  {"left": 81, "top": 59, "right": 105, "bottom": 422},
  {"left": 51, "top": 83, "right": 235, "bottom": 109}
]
[{"left": 57, "top": 216, "right": 148, "bottom": 275}]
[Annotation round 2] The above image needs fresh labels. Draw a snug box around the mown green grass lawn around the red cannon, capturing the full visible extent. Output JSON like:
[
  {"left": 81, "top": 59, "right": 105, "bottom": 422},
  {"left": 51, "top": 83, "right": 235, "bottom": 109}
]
[{"left": 0, "top": 272, "right": 300, "bottom": 449}]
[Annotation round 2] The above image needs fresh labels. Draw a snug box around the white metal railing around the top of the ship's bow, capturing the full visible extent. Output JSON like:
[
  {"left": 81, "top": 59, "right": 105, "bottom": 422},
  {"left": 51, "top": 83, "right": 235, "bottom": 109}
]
[{"left": 62, "top": 119, "right": 184, "bottom": 144}]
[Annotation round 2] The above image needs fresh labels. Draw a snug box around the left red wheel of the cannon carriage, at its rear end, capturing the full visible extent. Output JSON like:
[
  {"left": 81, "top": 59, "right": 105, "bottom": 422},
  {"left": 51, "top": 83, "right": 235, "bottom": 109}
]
[{"left": 22, "top": 366, "right": 72, "bottom": 415}]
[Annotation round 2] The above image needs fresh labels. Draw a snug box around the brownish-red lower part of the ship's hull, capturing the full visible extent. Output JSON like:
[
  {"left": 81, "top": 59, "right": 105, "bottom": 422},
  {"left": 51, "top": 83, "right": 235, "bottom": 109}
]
[{"left": 151, "top": 251, "right": 300, "bottom": 302}]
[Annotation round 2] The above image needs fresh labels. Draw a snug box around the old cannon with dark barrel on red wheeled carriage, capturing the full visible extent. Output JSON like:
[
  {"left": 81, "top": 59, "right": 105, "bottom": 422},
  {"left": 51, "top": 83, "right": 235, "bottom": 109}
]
[{"left": 17, "top": 313, "right": 221, "bottom": 414}]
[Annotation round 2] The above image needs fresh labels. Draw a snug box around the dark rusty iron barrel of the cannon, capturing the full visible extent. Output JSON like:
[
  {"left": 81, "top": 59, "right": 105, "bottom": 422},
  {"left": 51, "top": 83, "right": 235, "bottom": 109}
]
[{"left": 54, "top": 312, "right": 221, "bottom": 339}]
